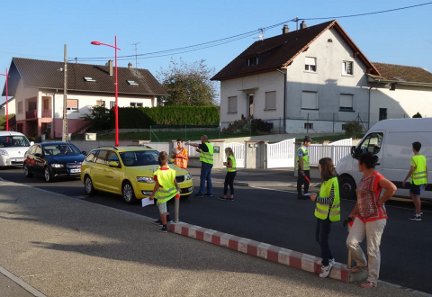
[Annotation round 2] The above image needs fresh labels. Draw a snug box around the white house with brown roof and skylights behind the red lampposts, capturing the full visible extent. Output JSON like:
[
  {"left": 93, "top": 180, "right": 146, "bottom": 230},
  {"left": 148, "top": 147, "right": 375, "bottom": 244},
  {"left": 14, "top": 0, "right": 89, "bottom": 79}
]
[{"left": 3, "top": 58, "right": 166, "bottom": 138}]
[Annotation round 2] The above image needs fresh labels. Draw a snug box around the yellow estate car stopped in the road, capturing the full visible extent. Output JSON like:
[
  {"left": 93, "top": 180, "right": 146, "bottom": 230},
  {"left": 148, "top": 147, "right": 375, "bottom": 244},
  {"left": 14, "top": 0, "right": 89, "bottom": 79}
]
[{"left": 81, "top": 146, "right": 193, "bottom": 203}]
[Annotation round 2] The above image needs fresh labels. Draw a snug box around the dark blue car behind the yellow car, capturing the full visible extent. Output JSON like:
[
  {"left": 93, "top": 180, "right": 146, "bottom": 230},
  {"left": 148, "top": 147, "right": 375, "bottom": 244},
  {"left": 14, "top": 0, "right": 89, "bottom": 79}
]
[{"left": 24, "top": 141, "right": 85, "bottom": 182}]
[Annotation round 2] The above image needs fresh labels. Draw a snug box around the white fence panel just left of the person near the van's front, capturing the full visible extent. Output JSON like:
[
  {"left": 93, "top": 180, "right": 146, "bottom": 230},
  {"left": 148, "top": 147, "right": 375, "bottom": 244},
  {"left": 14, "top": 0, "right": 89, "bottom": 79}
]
[{"left": 267, "top": 138, "right": 295, "bottom": 168}]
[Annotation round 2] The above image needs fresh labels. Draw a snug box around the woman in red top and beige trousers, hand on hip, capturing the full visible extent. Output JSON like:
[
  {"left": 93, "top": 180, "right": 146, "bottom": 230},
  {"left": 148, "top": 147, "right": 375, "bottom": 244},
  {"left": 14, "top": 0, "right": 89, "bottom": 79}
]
[{"left": 346, "top": 153, "right": 397, "bottom": 288}]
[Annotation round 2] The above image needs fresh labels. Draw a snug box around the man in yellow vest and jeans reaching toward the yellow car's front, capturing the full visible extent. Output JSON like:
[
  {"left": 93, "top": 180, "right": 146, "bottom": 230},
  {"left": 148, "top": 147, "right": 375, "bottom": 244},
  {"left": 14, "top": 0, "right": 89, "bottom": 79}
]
[{"left": 189, "top": 135, "right": 214, "bottom": 197}]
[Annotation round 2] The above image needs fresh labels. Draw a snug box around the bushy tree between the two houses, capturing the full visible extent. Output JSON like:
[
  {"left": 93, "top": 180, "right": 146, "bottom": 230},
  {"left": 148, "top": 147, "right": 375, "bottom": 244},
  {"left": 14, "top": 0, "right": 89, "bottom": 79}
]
[{"left": 158, "top": 60, "right": 216, "bottom": 106}]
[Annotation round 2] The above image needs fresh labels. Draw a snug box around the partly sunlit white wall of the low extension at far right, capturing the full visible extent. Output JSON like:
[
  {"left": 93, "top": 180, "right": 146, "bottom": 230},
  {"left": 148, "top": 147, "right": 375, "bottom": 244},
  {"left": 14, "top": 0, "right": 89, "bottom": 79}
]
[{"left": 371, "top": 86, "right": 432, "bottom": 126}]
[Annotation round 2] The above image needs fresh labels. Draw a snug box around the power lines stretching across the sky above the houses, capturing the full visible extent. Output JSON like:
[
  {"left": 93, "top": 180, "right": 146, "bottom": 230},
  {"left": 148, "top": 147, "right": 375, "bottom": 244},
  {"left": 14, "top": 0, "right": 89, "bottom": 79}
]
[{"left": 71, "top": 1, "right": 432, "bottom": 61}]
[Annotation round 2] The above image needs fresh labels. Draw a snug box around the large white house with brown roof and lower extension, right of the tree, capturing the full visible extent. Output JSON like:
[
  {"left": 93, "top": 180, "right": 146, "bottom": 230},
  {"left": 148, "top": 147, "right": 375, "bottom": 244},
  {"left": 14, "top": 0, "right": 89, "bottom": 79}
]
[{"left": 212, "top": 21, "right": 432, "bottom": 133}]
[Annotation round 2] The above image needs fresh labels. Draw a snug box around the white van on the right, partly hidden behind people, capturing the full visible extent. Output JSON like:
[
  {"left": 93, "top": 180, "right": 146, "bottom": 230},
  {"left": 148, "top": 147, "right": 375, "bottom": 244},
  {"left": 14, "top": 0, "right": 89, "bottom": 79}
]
[{"left": 336, "top": 118, "right": 432, "bottom": 199}]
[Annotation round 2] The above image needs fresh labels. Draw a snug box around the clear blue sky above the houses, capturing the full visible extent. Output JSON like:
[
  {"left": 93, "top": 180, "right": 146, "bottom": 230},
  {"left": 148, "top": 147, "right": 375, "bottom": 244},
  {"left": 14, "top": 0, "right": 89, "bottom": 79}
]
[{"left": 0, "top": 0, "right": 432, "bottom": 102}]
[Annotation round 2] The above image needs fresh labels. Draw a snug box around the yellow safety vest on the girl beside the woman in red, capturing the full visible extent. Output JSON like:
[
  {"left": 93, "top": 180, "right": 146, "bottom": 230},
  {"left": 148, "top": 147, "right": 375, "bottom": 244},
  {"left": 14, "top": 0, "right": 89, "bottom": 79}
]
[{"left": 315, "top": 177, "right": 340, "bottom": 222}]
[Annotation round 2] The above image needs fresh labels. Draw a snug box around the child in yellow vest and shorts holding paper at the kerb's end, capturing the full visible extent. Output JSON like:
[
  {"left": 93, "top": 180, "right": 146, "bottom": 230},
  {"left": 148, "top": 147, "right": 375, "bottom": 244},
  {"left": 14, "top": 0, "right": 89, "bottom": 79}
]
[{"left": 150, "top": 151, "right": 180, "bottom": 232}]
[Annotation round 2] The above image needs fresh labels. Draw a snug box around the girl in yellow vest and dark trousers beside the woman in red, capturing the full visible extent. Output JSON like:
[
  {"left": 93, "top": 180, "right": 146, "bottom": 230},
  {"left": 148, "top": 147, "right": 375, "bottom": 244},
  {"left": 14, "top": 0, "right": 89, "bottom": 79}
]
[{"left": 310, "top": 158, "right": 340, "bottom": 277}]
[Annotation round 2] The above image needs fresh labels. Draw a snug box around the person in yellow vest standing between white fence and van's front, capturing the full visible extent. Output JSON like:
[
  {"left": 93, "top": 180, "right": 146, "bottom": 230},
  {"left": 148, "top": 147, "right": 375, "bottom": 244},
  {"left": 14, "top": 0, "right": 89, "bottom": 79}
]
[{"left": 296, "top": 136, "right": 312, "bottom": 199}]
